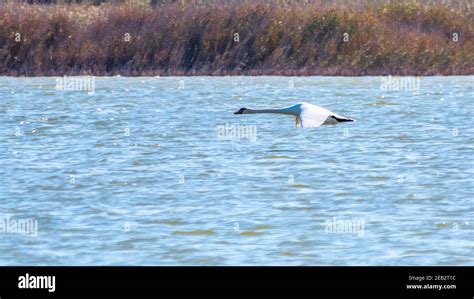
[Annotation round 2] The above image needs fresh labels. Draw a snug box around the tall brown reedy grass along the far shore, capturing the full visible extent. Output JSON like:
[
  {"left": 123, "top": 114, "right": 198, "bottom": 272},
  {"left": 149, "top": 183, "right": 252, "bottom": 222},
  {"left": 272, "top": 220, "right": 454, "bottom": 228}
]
[{"left": 0, "top": 0, "right": 474, "bottom": 76}]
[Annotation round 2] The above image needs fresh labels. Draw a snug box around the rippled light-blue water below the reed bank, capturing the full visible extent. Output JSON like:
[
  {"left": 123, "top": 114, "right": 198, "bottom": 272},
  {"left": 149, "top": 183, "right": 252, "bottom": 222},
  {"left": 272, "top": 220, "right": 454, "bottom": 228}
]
[{"left": 0, "top": 76, "right": 474, "bottom": 265}]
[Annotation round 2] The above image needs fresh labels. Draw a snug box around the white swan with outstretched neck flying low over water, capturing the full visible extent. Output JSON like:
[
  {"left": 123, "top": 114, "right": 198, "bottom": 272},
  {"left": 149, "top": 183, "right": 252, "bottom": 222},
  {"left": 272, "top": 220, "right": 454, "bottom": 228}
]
[{"left": 234, "top": 102, "right": 354, "bottom": 128}]
